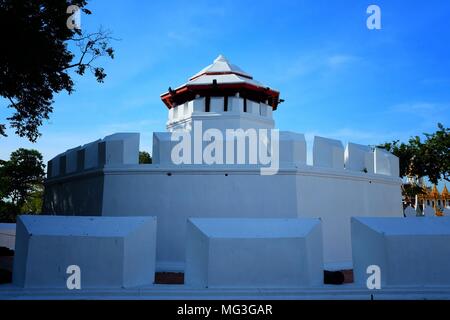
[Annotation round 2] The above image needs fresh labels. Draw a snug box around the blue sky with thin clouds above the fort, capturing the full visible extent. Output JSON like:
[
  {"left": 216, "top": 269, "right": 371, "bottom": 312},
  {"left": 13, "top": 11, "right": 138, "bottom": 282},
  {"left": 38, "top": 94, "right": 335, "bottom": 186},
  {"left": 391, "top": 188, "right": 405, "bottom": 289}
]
[{"left": 0, "top": 0, "right": 450, "bottom": 180}]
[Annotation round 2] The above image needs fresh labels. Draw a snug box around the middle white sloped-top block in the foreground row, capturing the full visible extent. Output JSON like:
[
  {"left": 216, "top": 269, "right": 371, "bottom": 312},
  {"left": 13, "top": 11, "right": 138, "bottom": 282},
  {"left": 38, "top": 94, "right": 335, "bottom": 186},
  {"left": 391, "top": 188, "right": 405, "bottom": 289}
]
[{"left": 185, "top": 218, "right": 323, "bottom": 288}]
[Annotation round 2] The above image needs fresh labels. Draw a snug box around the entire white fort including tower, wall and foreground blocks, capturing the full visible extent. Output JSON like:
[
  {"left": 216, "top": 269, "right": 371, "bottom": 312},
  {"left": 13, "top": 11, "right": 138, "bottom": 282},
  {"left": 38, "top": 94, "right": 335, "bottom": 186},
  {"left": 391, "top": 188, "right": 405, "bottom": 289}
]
[{"left": 0, "top": 56, "right": 450, "bottom": 299}]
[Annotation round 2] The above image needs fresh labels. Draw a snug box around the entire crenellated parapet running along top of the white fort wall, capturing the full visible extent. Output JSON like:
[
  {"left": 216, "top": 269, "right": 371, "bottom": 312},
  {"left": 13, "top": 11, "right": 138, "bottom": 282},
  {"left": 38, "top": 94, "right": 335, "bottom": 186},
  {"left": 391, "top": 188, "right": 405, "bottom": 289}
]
[{"left": 47, "top": 129, "right": 399, "bottom": 178}]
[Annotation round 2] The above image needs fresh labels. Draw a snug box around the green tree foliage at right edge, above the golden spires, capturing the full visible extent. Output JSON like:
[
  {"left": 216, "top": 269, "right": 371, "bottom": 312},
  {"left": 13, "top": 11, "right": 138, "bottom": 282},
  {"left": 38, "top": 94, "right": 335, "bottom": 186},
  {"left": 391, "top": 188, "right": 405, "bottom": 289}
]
[{"left": 379, "top": 123, "right": 450, "bottom": 184}]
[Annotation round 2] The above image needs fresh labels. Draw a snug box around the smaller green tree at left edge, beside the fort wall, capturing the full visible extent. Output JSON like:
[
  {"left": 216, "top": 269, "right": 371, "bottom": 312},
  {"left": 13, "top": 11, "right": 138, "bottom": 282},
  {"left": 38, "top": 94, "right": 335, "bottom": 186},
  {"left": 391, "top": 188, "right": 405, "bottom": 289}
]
[{"left": 0, "top": 148, "right": 45, "bottom": 221}]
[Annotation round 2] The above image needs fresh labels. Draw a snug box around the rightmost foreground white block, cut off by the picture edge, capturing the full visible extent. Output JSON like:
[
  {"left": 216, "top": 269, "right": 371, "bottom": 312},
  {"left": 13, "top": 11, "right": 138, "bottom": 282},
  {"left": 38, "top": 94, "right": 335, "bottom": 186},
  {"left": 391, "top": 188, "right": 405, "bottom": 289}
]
[{"left": 351, "top": 217, "right": 450, "bottom": 287}]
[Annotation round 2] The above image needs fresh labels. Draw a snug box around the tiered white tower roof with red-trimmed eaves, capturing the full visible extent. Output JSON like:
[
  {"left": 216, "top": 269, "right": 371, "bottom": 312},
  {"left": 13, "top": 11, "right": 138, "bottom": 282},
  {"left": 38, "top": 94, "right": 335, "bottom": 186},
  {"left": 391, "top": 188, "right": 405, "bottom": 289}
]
[{"left": 161, "top": 55, "right": 280, "bottom": 110}]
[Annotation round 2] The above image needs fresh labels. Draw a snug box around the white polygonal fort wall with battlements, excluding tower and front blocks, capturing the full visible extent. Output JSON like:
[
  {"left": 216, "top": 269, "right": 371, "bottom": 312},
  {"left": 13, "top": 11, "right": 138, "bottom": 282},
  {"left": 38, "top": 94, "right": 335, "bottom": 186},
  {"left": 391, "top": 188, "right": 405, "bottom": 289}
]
[{"left": 44, "top": 132, "right": 402, "bottom": 270}]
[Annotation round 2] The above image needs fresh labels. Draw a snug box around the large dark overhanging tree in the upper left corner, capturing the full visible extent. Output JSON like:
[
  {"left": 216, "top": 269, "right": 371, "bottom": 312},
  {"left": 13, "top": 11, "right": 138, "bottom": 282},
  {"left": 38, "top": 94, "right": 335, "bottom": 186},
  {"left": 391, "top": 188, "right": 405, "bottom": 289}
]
[{"left": 0, "top": 0, "right": 114, "bottom": 141}]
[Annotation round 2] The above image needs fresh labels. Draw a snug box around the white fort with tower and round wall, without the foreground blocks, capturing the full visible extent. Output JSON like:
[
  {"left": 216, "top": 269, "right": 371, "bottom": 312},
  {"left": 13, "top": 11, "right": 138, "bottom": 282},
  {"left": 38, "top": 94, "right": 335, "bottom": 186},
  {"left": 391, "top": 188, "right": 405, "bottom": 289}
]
[{"left": 44, "top": 56, "right": 403, "bottom": 271}]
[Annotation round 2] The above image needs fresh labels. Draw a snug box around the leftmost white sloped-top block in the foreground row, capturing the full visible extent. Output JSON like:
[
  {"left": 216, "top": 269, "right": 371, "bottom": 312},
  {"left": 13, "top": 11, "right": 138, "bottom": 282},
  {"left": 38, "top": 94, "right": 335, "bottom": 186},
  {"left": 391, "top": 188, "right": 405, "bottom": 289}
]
[{"left": 13, "top": 216, "right": 156, "bottom": 288}]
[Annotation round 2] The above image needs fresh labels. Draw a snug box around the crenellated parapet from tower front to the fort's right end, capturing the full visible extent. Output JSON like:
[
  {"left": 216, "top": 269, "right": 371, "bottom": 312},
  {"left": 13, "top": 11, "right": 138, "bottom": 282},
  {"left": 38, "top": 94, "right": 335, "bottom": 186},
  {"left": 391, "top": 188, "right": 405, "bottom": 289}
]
[{"left": 153, "top": 130, "right": 399, "bottom": 177}]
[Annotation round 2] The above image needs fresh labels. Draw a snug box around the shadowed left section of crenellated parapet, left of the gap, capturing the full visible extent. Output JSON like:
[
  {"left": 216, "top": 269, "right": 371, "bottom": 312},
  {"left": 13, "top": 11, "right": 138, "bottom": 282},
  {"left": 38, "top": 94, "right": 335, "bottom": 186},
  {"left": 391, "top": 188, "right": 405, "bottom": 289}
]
[{"left": 47, "top": 133, "right": 139, "bottom": 178}]
